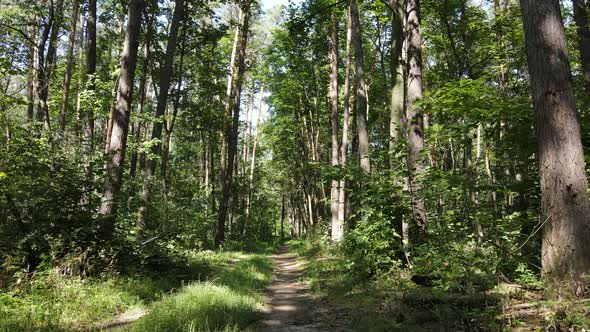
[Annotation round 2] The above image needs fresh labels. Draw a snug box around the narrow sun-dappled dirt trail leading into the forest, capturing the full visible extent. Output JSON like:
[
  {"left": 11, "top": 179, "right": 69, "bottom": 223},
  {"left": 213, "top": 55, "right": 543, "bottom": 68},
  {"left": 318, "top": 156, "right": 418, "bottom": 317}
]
[{"left": 262, "top": 246, "right": 347, "bottom": 331}]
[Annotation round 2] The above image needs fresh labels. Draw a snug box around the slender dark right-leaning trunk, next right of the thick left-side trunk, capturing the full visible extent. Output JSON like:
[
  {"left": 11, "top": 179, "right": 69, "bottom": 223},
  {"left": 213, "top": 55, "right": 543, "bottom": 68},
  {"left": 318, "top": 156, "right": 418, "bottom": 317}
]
[{"left": 137, "top": 0, "right": 184, "bottom": 228}]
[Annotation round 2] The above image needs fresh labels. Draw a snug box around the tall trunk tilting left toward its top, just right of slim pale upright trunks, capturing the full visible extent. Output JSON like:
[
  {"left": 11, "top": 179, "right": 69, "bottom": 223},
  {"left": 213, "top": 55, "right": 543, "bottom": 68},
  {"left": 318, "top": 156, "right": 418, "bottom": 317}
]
[{"left": 350, "top": 0, "right": 371, "bottom": 174}]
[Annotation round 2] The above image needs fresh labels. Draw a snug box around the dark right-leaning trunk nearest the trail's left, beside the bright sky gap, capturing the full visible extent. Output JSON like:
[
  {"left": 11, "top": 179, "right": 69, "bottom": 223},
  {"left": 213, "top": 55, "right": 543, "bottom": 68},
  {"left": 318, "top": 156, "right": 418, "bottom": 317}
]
[{"left": 215, "top": 0, "right": 251, "bottom": 246}]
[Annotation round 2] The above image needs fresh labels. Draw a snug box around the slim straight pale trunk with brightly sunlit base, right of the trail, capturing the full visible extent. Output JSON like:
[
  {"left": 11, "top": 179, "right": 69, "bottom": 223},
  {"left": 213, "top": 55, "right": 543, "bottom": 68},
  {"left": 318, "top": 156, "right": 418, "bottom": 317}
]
[{"left": 330, "top": 13, "right": 344, "bottom": 242}]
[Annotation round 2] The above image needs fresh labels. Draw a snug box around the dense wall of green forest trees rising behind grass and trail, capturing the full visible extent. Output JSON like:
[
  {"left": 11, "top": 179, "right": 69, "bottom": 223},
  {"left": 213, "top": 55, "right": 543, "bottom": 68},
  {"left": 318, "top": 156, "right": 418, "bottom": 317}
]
[{"left": 0, "top": 0, "right": 590, "bottom": 300}]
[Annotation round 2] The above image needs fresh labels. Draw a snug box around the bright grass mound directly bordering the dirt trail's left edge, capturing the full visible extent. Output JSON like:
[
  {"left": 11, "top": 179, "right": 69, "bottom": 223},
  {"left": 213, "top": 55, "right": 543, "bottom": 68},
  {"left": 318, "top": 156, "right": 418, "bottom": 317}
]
[{"left": 132, "top": 252, "right": 272, "bottom": 332}]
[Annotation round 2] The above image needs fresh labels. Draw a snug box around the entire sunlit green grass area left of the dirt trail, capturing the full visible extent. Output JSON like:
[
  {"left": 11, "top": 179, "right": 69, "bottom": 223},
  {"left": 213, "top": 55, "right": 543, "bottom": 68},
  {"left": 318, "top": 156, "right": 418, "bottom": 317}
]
[{"left": 0, "top": 245, "right": 273, "bottom": 332}]
